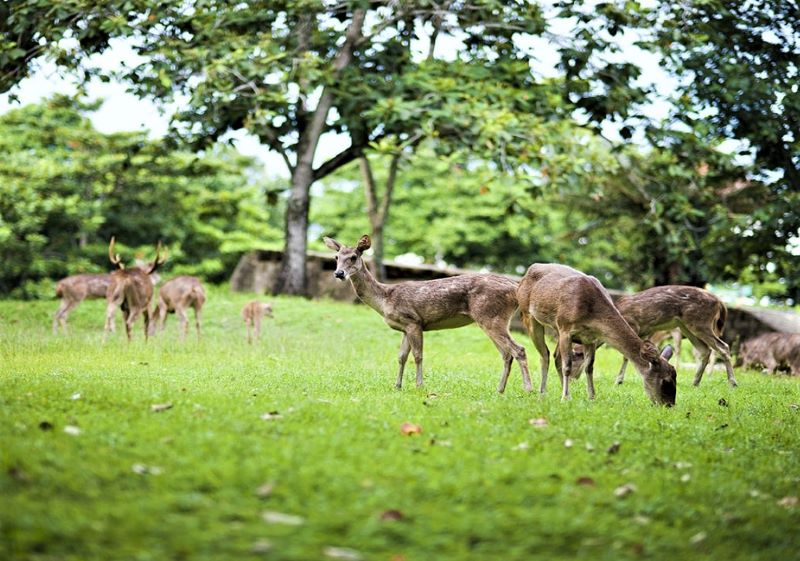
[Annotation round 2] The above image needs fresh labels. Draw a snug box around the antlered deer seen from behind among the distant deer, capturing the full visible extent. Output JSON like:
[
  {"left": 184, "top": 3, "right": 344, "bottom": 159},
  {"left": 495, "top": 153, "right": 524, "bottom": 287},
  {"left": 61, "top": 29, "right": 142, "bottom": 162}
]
[{"left": 103, "top": 237, "right": 166, "bottom": 342}]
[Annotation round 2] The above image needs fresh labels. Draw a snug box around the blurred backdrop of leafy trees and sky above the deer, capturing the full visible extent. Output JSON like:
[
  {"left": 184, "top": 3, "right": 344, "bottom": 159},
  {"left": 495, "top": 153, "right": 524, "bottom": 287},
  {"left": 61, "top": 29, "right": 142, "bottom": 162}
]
[{"left": 0, "top": 0, "right": 800, "bottom": 306}]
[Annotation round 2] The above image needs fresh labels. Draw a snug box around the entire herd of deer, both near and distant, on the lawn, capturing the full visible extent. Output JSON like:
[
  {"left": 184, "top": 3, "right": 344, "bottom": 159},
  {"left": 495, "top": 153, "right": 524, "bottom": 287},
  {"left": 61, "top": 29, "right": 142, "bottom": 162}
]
[{"left": 53, "top": 235, "right": 800, "bottom": 406}]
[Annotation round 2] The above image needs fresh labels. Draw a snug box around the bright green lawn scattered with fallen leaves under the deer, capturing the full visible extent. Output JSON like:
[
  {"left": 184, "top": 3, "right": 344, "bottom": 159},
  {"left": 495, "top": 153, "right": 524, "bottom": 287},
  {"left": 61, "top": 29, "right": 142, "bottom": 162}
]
[{"left": 0, "top": 290, "right": 800, "bottom": 561}]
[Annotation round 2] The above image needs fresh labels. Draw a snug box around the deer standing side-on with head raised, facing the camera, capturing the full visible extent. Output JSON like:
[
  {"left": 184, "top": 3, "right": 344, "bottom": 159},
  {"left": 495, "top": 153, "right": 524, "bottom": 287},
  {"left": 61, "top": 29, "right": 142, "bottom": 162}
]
[{"left": 323, "top": 235, "right": 531, "bottom": 393}]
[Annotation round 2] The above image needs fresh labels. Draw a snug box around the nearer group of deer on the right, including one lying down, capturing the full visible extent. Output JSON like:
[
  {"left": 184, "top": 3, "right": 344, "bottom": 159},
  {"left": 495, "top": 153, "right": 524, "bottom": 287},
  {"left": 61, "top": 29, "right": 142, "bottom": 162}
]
[{"left": 323, "top": 236, "right": 800, "bottom": 406}]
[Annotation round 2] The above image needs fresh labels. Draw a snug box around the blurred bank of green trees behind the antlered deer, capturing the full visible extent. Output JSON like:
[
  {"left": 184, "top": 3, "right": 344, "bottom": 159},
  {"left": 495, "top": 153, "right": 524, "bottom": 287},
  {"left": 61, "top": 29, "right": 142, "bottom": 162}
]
[{"left": 0, "top": 96, "right": 280, "bottom": 296}]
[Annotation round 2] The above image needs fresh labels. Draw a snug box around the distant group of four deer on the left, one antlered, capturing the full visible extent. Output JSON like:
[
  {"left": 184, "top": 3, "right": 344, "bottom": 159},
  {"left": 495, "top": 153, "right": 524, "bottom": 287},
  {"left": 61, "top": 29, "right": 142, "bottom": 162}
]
[{"left": 53, "top": 238, "right": 272, "bottom": 343}]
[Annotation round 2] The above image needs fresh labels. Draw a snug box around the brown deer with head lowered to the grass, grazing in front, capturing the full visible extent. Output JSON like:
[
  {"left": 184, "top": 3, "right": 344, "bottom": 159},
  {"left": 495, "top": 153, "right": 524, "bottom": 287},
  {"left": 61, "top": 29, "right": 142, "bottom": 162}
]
[{"left": 517, "top": 263, "right": 677, "bottom": 406}]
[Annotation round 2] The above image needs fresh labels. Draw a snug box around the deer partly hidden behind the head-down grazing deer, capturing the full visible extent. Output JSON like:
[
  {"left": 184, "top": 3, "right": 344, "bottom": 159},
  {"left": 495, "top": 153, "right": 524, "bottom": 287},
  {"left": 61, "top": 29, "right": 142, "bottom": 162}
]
[{"left": 616, "top": 285, "right": 737, "bottom": 387}]
